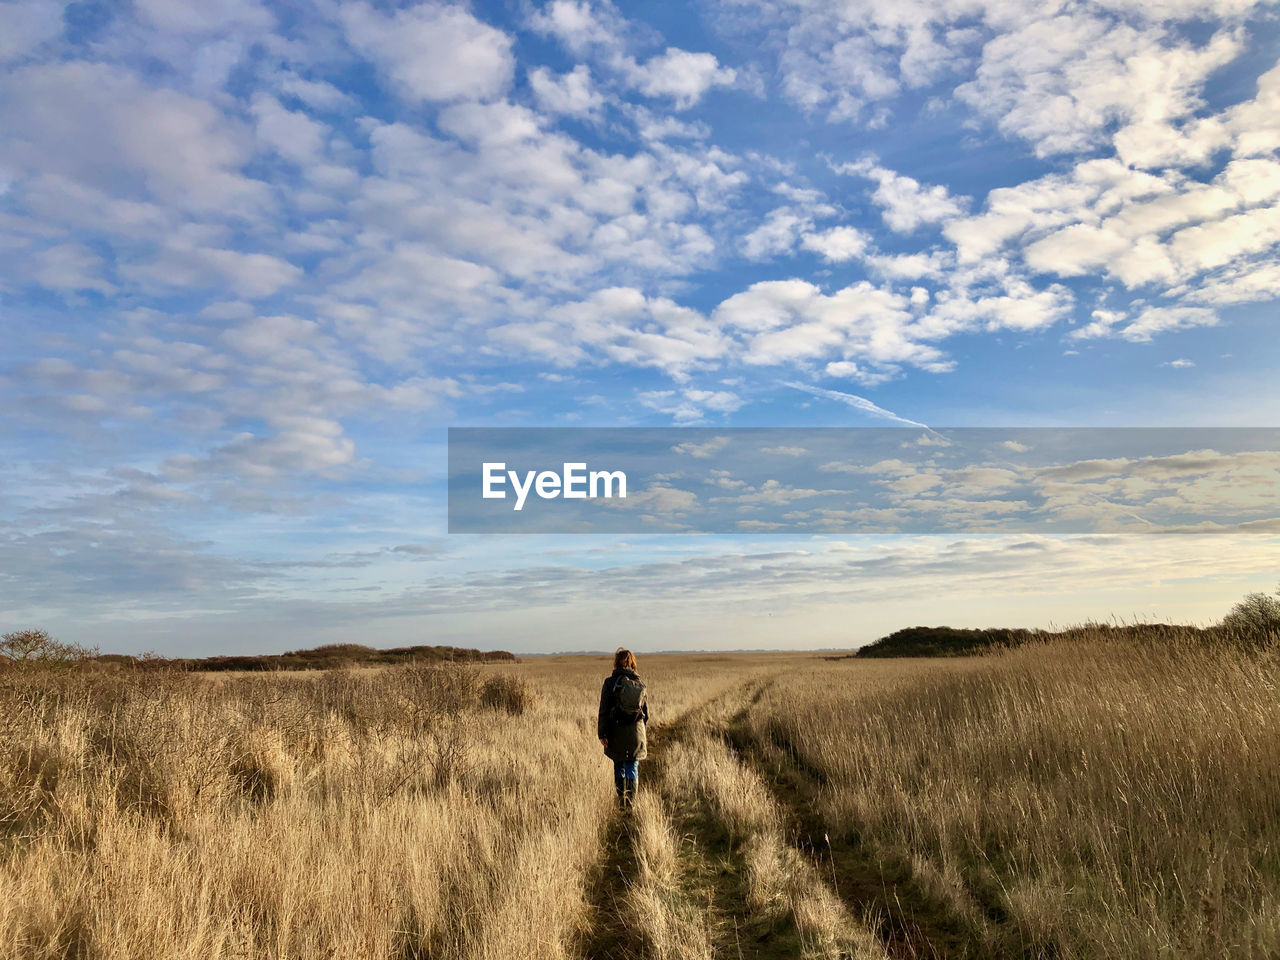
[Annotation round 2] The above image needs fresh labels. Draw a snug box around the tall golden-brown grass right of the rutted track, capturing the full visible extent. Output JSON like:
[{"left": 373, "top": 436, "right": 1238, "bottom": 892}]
[{"left": 749, "top": 632, "right": 1280, "bottom": 959}]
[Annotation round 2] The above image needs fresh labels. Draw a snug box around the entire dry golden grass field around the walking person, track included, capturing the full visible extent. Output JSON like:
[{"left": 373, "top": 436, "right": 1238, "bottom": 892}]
[{"left": 0, "top": 635, "right": 1280, "bottom": 960}]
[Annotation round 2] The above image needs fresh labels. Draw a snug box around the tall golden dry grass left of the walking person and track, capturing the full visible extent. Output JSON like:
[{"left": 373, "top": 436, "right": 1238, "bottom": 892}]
[{"left": 0, "top": 668, "right": 609, "bottom": 960}]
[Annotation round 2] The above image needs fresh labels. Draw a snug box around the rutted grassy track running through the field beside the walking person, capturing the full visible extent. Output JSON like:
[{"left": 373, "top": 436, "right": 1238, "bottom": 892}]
[{"left": 582, "top": 680, "right": 886, "bottom": 960}]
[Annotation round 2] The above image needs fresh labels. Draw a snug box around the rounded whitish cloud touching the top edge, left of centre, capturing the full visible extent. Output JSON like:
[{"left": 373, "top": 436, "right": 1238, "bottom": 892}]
[{"left": 340, "top": 1, "right": 515, "bottom": 102}]
